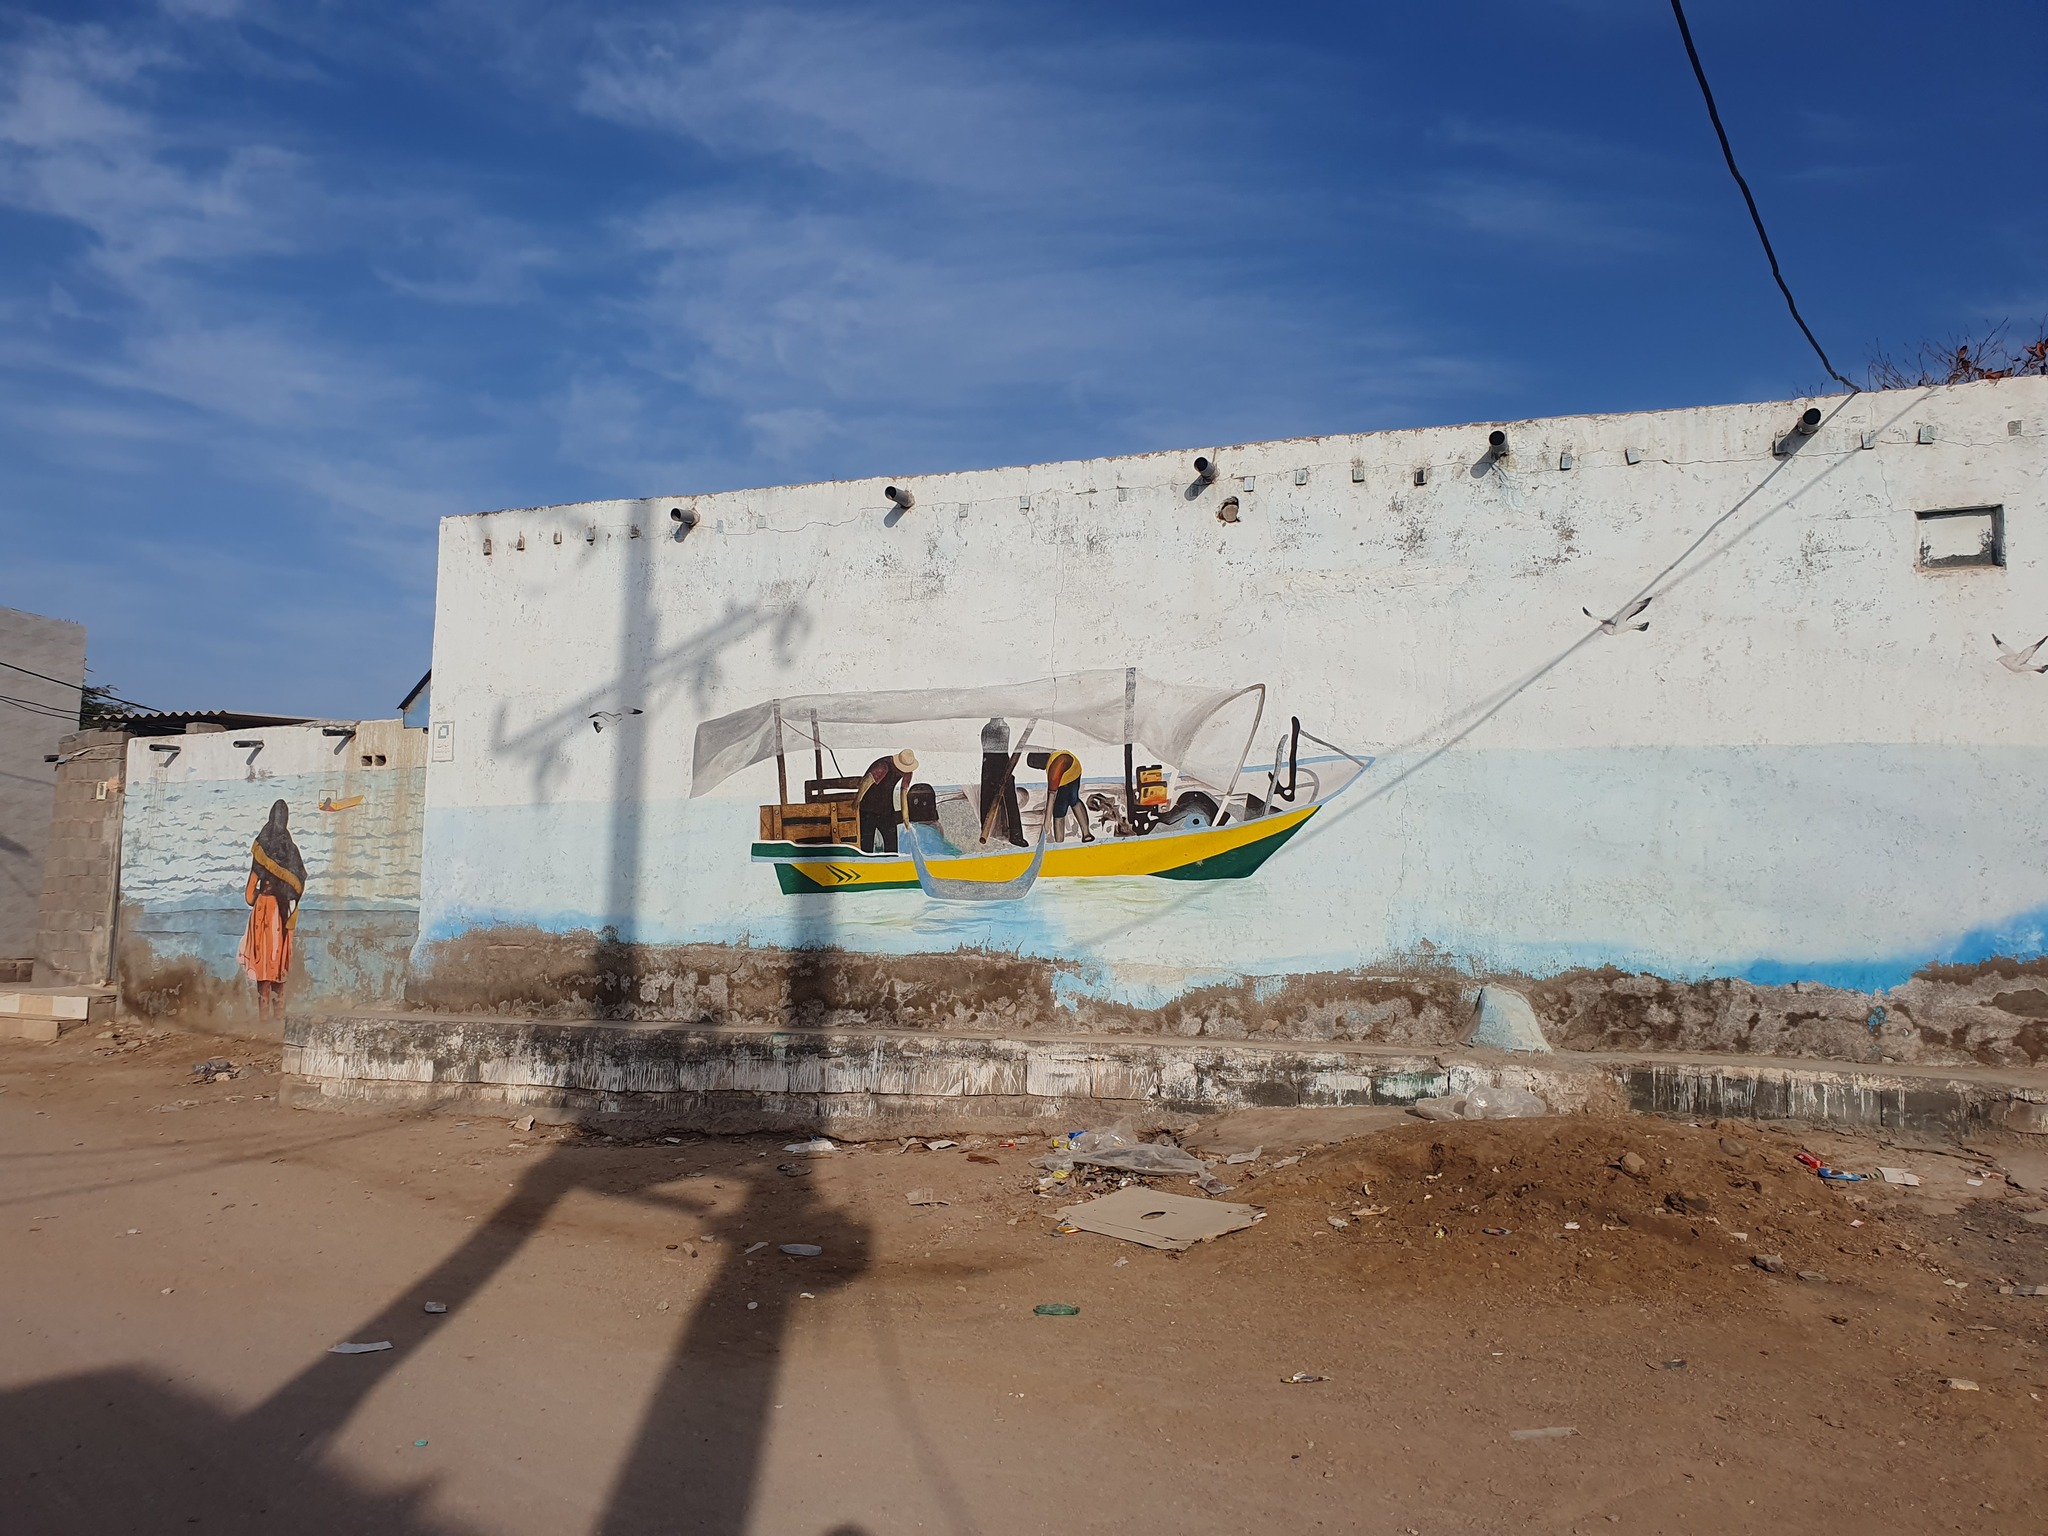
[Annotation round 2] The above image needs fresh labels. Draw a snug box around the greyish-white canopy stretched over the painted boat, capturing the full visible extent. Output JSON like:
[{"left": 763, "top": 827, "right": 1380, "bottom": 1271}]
[{"left": 690, "top": 668, "right": 1266, "bottom": 797}]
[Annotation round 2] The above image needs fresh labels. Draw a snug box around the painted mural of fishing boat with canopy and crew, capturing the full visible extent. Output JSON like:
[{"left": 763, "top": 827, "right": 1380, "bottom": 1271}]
[{"left": 690, "top": 668, "right": 1372, "bottom": 901}]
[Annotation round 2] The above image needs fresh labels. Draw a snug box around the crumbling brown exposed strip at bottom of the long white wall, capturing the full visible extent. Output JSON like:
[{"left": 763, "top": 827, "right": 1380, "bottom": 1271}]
[{"left": 406, "top": 928, "right": 2048, "bottom": 1067}]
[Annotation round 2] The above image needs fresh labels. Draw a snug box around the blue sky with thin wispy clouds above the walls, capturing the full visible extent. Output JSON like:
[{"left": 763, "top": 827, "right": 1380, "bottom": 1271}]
[{"left": 0, "top": 0, "right": 2048, "bottom": 717}]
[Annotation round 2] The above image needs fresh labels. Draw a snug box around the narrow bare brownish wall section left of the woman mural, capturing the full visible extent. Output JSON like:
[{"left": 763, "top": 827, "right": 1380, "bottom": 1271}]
[{"left": 35, "top": 731, "right": 129, "bottom": 987}]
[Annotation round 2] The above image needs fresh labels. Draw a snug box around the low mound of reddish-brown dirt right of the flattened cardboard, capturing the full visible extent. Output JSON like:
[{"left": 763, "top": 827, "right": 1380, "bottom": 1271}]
[{"left": 1204, "top": 1116, "right": 1915, "bottom": 1298}]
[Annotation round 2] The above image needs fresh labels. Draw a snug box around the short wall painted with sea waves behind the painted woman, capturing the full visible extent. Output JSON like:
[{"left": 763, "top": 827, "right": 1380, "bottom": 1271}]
[{"left": 119, "top": 721, "right": 426, "bottom": 1024}]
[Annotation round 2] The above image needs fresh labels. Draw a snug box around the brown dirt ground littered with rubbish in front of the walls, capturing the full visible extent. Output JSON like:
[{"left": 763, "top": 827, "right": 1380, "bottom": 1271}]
[{"left": 0, "top": 1034, "right": 2048, "bottom": 1536}]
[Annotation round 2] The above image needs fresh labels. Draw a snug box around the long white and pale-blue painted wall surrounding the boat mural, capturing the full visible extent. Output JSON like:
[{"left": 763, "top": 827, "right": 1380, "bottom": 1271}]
[{"left": 412, "top": 379, "right": 2048, "bottom": 1061}]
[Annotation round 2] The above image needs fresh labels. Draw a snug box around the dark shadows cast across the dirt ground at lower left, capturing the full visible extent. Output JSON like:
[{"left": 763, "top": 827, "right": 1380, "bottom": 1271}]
[{"left": 0, "top": 1145, "right": 868, "bottom": 1536}]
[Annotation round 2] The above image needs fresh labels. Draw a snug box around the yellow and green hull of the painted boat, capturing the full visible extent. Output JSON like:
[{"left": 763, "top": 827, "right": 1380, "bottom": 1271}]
[{"left": 754, "top": 805, "right": 1323, "bottom": 895}]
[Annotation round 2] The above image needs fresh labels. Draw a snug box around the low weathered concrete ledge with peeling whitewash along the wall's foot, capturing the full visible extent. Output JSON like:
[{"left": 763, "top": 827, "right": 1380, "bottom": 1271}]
[{"left": 285, "top": 1014, "right": 2048, "bottom": 1139}]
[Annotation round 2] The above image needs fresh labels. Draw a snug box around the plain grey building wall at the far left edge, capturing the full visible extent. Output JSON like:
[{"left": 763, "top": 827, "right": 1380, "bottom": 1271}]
[{"left": 0, "top": 608, "right": 86, "bottom": 963}]
